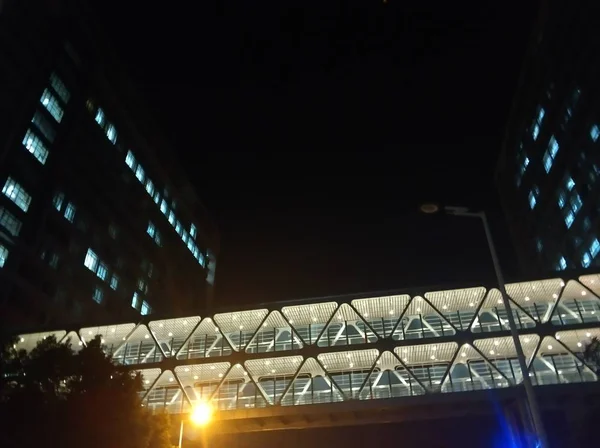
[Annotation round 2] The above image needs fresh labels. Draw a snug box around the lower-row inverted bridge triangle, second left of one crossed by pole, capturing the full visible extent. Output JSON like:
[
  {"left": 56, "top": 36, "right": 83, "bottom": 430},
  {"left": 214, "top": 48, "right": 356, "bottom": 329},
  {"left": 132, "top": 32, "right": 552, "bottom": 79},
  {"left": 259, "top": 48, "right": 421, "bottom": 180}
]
[{"left": 317, "top": 349, "right": 379, "bottom": 398}]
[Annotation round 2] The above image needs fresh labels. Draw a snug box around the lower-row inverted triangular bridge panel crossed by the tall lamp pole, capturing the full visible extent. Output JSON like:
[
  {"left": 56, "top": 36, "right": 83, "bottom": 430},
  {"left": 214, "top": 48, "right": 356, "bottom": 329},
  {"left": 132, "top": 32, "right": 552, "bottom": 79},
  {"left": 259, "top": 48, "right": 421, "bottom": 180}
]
[{"left": 473, "top": 334, "right": 540, "bottom": 385}]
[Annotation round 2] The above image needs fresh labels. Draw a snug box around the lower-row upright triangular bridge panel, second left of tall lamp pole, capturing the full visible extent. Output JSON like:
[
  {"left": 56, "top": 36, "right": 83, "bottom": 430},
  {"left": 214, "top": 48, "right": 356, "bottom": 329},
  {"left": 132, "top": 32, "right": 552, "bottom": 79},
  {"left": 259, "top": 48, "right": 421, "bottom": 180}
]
[{"left": 358, "top": 351, "right": 425, "bottom": 400}]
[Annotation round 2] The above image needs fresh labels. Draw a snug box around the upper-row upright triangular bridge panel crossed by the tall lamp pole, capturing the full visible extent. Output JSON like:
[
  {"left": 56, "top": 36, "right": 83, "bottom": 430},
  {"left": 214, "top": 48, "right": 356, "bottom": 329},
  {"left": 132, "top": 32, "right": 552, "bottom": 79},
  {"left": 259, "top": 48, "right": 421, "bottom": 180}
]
[{"left": 471, "top": 289, "right": 536, "bottom": 333}]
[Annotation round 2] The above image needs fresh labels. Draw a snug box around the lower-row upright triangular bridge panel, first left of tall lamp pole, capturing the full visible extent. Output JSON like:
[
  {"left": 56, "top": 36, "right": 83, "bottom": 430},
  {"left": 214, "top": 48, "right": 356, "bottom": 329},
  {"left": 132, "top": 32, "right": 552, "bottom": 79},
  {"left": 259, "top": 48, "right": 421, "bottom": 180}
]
[{"left": 442, "top": 344, "right": 510, "bottom": 393}]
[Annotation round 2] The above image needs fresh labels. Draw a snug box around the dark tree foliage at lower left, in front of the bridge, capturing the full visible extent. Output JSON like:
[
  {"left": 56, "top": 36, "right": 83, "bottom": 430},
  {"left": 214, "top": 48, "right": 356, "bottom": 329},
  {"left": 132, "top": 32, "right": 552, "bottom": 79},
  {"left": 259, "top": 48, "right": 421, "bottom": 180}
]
[{"left": 0, "top": 337, "right": 171, "bottom": 448}]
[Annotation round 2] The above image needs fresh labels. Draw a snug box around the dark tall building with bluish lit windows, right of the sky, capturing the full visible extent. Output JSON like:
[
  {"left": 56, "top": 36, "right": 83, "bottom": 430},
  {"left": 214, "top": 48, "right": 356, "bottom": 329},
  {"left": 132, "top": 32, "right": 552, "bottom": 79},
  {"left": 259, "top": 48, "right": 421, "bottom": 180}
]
[{"left": 496, "top": 0, "right": 600, "bottom": 275}]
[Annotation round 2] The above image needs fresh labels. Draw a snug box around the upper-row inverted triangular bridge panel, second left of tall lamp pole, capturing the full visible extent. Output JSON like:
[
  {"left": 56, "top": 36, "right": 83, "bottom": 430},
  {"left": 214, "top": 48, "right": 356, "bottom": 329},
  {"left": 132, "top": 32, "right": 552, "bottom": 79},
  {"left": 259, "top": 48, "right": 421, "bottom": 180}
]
[{"left": 352, "top": 294, "right": 410, "bottom": 338}]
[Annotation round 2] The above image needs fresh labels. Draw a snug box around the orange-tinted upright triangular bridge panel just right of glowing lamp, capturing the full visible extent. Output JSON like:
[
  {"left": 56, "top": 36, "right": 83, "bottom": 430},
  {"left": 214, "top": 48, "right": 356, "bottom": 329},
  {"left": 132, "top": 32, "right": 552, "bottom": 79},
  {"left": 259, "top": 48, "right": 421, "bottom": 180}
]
[{"left": 212, "top": 364, "right": 267, "bottom": 410}]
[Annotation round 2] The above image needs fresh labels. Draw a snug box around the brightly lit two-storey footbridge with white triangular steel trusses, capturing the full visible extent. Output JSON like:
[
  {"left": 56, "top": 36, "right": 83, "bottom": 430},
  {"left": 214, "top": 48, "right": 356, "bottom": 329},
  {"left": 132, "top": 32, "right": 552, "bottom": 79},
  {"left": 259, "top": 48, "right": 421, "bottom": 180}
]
[{"left": 18, "top": 274, "right": 600, "bottom": 413}]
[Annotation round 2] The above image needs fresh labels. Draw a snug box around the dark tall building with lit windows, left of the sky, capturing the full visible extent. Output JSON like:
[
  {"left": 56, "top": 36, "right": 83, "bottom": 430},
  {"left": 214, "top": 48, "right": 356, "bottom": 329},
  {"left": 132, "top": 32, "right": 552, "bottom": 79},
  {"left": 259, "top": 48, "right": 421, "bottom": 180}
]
[{"left": 0, "top": 0, "right": 218, "bottom": 328}]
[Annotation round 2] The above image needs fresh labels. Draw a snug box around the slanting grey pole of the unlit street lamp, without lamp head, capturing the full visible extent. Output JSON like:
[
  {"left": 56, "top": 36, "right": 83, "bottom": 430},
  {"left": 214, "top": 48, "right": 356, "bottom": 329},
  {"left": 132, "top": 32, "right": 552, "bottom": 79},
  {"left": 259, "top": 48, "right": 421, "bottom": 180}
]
[{"left": 476, "top": 212, "right": 549, "bottom": 448}]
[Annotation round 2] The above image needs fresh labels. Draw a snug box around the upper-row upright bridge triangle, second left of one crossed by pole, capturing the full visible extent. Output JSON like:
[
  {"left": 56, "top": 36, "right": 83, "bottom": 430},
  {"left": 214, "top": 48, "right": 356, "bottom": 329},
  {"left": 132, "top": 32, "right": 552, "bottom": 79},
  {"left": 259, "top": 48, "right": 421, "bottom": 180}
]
[{"left": 317, "top": 303, "right": 377, "bottom": 347}]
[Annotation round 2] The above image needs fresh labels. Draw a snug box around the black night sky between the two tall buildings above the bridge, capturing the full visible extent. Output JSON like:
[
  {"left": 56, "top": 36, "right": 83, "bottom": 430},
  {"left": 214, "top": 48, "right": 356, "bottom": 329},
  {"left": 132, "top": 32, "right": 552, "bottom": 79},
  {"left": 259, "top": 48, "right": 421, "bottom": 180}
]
[{"left": 105, "top": 0, "right": 536, "bottom": 305}]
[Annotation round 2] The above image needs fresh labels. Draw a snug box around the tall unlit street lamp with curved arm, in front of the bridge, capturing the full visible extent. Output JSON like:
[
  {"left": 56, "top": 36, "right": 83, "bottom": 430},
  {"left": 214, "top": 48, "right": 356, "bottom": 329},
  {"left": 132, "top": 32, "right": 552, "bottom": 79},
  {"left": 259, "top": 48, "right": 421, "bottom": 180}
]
[{"left": 419, "top": 204, "right": 548, "bottom": 448}]
